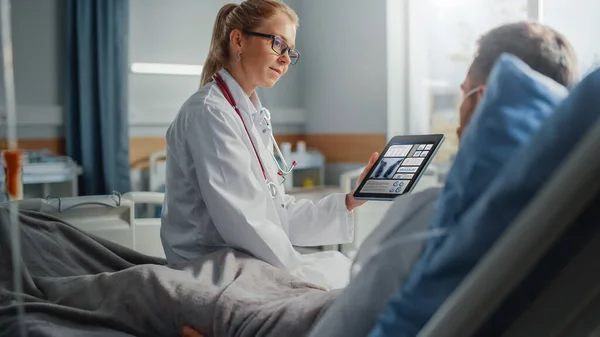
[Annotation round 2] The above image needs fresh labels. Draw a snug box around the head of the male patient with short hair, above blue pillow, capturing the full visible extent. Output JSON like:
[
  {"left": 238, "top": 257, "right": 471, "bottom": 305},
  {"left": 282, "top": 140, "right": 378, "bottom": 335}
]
[{"left": 456, "top": 22, "right": 578, "bottom": 139}]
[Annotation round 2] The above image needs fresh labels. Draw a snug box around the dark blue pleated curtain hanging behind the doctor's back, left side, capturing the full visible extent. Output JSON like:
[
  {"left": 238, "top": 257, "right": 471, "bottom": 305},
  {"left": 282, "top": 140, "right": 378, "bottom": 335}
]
[{"left": 65, "top": 0, "right": 130, "bottom": 195}]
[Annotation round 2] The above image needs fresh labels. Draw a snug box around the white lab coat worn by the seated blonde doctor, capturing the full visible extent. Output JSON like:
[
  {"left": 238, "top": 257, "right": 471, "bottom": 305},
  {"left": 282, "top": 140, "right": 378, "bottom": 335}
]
[{"left": 161, "top": 70, "right": 354, "bottom": 289}]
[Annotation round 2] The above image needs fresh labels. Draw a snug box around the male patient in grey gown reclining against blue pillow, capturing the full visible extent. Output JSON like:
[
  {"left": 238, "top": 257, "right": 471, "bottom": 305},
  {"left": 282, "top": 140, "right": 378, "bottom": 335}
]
[{"left": 311, "top": 22, "right": 578, "bottom": 337}]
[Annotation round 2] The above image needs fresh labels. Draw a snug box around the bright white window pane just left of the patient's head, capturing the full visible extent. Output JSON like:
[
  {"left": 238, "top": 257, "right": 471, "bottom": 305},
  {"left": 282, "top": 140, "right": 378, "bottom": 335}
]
[{"left": 422, "top": 0, "right": 528, "bottom": 163}]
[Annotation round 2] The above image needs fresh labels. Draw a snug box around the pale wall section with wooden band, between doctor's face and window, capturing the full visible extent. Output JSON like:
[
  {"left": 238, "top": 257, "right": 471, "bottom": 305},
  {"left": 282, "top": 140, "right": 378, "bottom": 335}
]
[{"left": 298, "top": 0, "right": 387, "bottom": 184}]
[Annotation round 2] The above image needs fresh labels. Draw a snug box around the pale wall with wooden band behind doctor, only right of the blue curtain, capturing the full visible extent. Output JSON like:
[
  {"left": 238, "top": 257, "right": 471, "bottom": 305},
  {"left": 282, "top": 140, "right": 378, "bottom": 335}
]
[{"left": 129, "top": 0, "right": 394, "bottom": 184}]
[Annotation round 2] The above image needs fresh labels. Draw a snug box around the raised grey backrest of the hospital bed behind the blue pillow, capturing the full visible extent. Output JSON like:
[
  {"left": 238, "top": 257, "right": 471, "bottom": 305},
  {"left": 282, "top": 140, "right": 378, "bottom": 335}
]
[{"left": 418, "top": 105, "right": 600, "bottom": 337}]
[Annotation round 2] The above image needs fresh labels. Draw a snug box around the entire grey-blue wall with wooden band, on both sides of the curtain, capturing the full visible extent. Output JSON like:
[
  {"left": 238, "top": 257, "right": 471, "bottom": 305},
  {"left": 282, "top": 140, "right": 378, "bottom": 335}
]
[{"left": 0, "top": 0, "right": 394, "bottom": 186}]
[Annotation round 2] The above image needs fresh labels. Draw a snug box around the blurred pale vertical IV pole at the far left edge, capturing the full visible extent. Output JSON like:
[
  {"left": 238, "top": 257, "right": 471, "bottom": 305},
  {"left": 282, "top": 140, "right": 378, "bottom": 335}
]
[{"left": 0, "top": 0, "right": 27, "bottom": 337}]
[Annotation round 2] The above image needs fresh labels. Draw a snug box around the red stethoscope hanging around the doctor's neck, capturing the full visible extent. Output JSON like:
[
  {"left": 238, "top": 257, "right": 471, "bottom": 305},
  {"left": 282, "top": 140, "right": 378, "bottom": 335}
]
[{"left": 213, "top": 74, "right": 297, "bottom": 199}]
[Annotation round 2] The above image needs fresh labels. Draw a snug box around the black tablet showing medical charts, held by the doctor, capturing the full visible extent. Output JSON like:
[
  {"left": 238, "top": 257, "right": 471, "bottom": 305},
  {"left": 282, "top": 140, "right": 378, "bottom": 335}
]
[{"left": 354, "top": 134, "right": 444, "bottom": 200}]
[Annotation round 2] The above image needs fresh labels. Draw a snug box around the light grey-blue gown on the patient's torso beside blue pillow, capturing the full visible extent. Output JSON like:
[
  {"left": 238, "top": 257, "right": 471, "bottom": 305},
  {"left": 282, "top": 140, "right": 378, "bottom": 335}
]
[{"left": 310, "top": 187, "right": 443, "bottom": 337}]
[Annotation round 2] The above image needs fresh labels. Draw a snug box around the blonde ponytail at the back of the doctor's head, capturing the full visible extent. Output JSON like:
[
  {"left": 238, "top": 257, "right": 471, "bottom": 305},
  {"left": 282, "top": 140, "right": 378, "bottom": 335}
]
[{"left": 200, "top": 4, "right": 238, "bottom": 87}]
